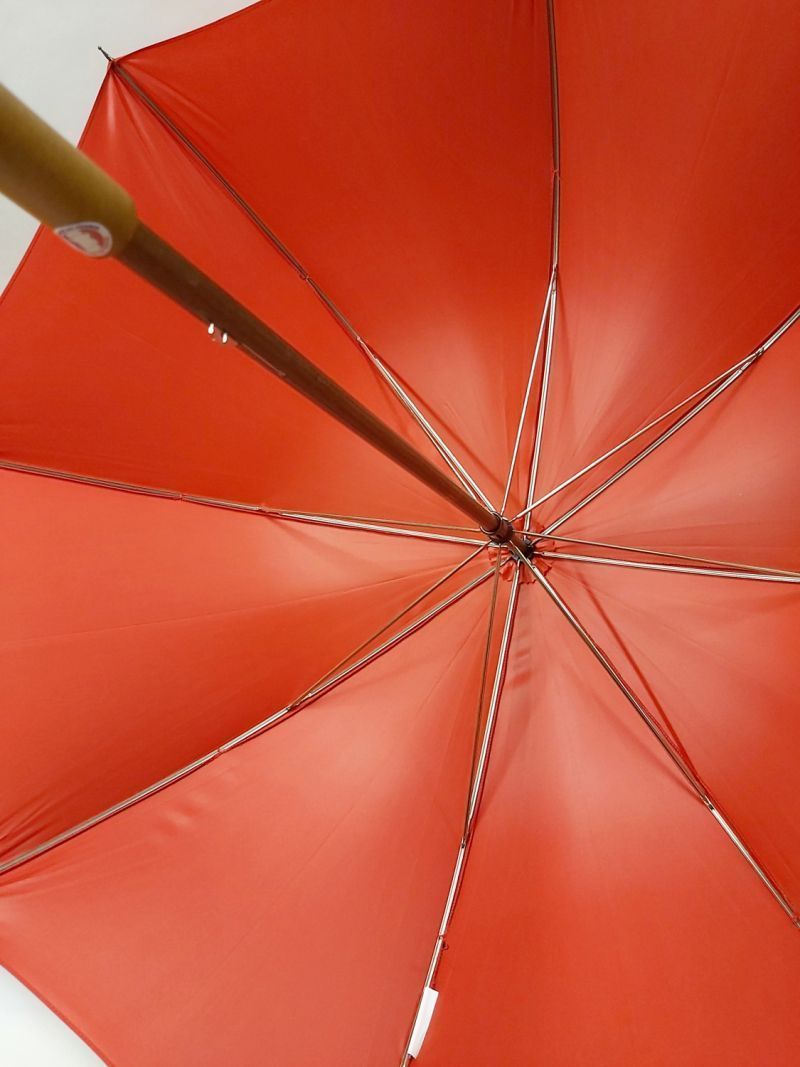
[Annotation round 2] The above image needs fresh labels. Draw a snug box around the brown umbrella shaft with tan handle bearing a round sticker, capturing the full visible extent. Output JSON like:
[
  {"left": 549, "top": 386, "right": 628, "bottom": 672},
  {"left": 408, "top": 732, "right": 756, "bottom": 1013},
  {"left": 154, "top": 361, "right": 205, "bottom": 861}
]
[{"left": 0, "top": 86, "right": 527, "bottom": 551}]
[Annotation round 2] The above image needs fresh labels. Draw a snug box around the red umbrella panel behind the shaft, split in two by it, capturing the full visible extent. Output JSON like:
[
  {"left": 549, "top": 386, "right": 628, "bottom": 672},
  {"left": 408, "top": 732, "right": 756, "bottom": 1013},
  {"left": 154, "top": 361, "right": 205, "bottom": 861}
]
[{"left": 0, "top": 72, "right": 462, "bottom": 522}]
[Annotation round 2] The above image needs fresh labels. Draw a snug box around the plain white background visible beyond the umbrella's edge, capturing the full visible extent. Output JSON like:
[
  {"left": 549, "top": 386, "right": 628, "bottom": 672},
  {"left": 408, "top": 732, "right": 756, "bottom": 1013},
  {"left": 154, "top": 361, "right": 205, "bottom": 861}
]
[{"left": 0, "top": 0, "right": 247, "bottom": 1067}]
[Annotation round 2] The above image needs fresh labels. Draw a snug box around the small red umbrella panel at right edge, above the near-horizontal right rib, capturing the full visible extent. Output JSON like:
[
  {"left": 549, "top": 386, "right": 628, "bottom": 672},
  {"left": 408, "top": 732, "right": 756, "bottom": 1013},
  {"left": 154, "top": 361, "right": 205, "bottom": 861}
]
[{"left": 554, "top": 324, "right": 800, "bottom": 580}]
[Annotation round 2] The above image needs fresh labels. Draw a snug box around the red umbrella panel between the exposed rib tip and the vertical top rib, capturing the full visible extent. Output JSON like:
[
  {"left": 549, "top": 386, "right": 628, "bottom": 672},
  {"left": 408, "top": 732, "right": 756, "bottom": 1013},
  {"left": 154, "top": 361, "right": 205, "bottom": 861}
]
[{"left": 124, "top": 0, "right": 551, "bottom": 512}]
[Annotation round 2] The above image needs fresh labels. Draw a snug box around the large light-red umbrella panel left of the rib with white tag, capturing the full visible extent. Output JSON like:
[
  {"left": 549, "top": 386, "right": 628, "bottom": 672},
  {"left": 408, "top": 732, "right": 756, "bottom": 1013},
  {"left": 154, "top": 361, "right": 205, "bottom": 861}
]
[{"left": 0, "top": 588, "right": 487, "bottom": 1067}]
